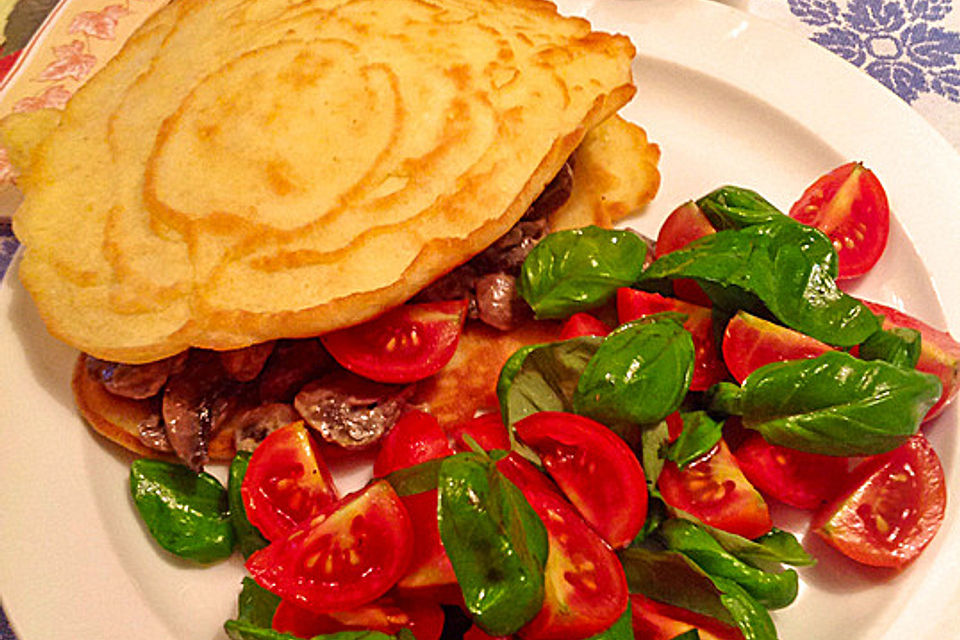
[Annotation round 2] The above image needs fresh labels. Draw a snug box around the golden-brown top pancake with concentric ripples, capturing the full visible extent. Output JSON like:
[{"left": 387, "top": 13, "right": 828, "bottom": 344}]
[{"left": 6, "top": 0, "right": 634, "bottom": 362}]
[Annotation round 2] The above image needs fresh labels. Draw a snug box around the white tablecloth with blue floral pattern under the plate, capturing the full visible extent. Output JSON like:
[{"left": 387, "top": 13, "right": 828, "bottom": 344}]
[{"left": 0, "top": 0, "right": 960, "bottom": 640}]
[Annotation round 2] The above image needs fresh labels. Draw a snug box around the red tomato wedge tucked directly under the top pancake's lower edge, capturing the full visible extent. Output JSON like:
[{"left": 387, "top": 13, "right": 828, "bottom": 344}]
[{"left": 320, "top": 300, "right": 467, "bottom": 383}]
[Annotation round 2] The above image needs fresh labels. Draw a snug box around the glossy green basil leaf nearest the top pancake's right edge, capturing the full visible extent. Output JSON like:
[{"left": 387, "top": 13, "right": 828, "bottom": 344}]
[{"left": 519, "top": 226, "right": 647, "bottom": 318}]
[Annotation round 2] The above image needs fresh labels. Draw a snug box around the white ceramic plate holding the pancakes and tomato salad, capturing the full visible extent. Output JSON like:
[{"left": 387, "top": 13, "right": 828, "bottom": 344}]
[{"left": 0, "top": 0, "right": 960, "bottom": 640}]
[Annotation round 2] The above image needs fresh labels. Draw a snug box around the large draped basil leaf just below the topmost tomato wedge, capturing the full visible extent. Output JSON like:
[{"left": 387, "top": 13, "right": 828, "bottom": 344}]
[{"left": 640, "top": 220, "right": 880, "bottom": 346}]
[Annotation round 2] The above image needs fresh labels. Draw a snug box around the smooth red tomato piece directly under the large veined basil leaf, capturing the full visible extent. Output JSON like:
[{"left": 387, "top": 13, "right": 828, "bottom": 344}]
[{"left": 734, "top": 433, "right": 849, "bottom": 509}]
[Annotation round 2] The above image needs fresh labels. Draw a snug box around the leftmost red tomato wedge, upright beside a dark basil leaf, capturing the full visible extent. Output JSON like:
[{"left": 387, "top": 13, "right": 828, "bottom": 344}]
[{"left": 240, "top": 422, "right": 340, "bottom": 540}]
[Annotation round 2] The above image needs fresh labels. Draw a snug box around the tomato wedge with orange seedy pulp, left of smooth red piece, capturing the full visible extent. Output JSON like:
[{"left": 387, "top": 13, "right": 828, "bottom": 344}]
[{"left": 657, "top": 440, "right": 773, "bottom": 539}]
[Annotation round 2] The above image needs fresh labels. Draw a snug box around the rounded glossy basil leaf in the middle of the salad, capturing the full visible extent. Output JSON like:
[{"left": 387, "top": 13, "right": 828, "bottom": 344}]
[{"left": 573, "top": 314, "right": 694, "bottom": 424}]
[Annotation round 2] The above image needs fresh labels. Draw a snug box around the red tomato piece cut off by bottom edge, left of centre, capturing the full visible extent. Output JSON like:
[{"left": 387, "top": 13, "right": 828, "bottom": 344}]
[{"left": 272, "top": 596, "right": 443, "bottom": 640}]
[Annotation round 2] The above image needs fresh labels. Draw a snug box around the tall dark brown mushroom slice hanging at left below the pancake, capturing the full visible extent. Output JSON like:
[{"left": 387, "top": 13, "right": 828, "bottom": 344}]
[{"left": 162, "top": 351, "right": 242, "bottom": 471}]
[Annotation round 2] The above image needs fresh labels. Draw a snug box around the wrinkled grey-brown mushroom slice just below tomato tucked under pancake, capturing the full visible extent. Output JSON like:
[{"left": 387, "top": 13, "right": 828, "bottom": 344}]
[{"left": 294, "top": 371, "right": 414, "bottom": 450}]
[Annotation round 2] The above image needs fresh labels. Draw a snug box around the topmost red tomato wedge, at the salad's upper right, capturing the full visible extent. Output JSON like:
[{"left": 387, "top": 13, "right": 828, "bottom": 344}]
[{"left": 790, "top": 162, "right": 890, "bottom": 279}]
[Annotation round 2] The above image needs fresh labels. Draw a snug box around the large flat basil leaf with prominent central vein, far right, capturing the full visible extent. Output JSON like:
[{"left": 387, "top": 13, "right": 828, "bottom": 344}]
[{"left": 720, "top": 351, "right": 941, "bottom": 456}]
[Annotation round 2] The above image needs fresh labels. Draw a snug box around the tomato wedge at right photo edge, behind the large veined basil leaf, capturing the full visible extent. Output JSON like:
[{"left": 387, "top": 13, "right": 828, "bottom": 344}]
[{"left": 863, "top": 300, "right": 960, "bottom": 421}]
